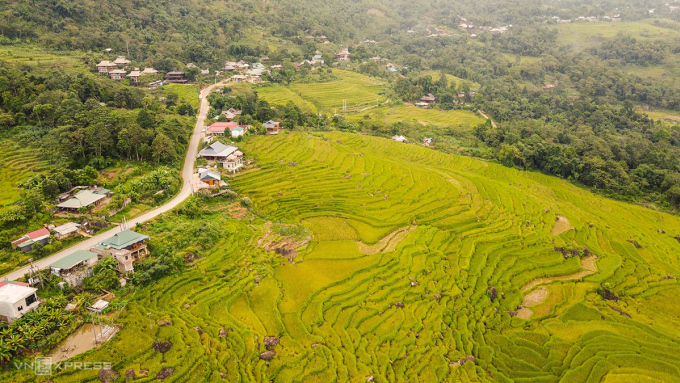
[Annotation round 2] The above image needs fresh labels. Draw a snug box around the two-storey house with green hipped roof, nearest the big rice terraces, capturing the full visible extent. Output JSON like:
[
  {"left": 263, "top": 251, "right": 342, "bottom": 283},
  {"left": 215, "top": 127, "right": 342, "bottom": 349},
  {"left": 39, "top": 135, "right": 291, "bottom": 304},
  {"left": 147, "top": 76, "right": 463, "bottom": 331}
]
[{"left": 92, "top": 229, "right": 149, "bottom": 274}]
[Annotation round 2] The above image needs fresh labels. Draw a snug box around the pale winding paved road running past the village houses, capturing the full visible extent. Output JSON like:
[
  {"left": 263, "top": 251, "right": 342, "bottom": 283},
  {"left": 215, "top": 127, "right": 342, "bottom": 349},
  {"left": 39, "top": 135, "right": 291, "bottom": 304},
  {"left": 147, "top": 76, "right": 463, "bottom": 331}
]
[{"left": 2, "top": 82, "right": 223, "bottom": 281}]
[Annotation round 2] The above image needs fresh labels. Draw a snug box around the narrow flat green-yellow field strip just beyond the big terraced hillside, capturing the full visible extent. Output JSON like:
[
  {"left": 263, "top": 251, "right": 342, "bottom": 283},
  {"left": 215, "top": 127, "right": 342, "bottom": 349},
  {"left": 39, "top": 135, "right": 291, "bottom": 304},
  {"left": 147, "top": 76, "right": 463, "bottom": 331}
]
[{"left": 347, "top": 104, "right": 484, "bottom": 127}]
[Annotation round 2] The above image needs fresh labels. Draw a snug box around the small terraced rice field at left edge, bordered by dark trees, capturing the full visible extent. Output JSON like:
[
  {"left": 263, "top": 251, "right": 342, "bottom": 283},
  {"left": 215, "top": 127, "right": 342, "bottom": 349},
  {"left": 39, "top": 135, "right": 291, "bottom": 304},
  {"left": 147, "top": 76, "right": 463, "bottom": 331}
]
[{"left": 0, "top": 141, "right": 49, "bottom": 211}]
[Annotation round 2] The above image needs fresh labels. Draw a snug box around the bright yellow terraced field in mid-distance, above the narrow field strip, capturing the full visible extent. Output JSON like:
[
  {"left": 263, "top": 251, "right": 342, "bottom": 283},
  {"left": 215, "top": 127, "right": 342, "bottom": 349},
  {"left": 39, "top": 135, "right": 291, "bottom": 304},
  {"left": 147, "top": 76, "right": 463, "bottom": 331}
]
[{"left": 290, "top": 69, "right": 385, "bottom": 111}]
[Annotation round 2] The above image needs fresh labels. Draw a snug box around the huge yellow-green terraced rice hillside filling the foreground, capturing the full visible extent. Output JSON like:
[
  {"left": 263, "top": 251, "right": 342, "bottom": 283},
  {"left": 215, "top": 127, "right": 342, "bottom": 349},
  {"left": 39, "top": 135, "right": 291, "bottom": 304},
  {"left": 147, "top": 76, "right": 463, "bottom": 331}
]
[{"left": 34, "top": 133, "right": 680, "bottom": 383}]
